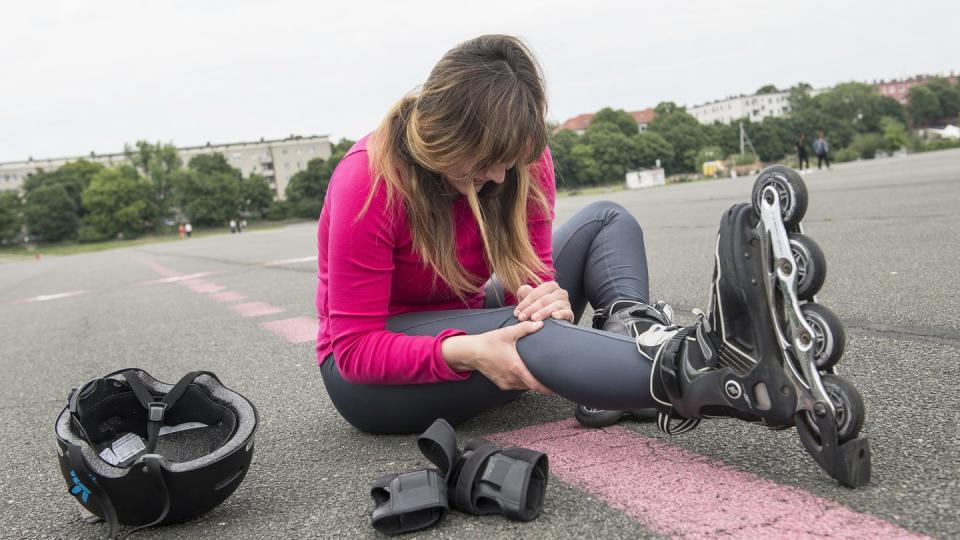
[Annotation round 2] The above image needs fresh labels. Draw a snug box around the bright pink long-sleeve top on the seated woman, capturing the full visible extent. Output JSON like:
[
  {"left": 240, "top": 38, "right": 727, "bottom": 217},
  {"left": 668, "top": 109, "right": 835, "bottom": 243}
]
[{"left": 316, "top": 137, "right": 556, "bottom": 384}]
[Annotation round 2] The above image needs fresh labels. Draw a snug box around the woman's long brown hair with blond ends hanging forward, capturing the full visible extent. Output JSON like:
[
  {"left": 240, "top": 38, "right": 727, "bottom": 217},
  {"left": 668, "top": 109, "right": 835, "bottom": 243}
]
[{"left": 358, "top": 35, "right": 550, "bottom": 300}]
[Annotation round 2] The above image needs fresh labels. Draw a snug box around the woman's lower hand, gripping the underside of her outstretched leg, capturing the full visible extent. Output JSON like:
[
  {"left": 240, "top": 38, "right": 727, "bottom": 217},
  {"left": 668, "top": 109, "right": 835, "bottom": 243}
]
[{"left": 441, "top": 321, "right": 553, "bottom": 395}]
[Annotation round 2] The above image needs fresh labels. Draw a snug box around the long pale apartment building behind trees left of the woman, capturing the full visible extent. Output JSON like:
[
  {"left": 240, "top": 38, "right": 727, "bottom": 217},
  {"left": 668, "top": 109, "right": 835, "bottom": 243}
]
[{"left": 0, "top": 135, "right": 333, "bottom": 199}]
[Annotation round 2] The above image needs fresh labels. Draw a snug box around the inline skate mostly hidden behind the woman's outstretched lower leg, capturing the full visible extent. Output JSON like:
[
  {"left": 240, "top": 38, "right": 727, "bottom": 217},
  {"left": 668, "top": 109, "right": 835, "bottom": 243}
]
[{"left": 574, "top": 299, "right": 677, "bottom": 428}]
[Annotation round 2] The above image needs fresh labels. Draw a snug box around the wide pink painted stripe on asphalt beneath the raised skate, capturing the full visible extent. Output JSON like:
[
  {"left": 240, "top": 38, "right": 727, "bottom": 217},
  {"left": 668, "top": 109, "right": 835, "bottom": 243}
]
[{"left": 487, "top": 419, "right": 926, "bottom": 538}]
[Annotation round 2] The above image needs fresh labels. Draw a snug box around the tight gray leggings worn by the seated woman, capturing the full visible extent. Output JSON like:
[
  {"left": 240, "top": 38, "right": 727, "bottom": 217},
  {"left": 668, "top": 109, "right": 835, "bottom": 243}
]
[{"left": 320, "top": 201, "right": 654, "bottom": 433}]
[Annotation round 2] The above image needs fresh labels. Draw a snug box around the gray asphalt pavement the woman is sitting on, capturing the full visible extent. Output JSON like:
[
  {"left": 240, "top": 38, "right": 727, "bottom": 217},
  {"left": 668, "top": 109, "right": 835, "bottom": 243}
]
[{"left": 0, "top": 150, "right": 960, "bottom": 538}]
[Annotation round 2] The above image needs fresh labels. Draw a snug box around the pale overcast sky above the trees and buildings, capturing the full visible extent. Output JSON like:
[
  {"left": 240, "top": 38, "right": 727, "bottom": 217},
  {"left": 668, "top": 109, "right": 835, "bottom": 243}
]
[{"left": 0, "top": 0, "right": 960, "bottom": 161}]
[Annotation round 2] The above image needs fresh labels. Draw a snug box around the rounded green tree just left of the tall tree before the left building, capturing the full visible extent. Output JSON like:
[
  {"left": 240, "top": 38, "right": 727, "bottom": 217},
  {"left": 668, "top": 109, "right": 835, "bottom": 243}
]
[{"left": 81, "top": 166, "right": 152, "bottom": 240}]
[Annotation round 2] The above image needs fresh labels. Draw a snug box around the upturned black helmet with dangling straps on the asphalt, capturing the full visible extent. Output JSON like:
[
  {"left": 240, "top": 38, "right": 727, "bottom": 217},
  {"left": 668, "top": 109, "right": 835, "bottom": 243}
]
[{"left": 56, "top": 369, "right": 258, "bottom": 537}]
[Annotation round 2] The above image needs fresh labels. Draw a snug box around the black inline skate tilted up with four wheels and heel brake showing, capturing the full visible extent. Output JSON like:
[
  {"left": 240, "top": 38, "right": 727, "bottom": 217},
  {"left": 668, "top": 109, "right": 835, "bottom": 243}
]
[{"left": 637, "top": 165, "right": 870, "bottom": 487}]
